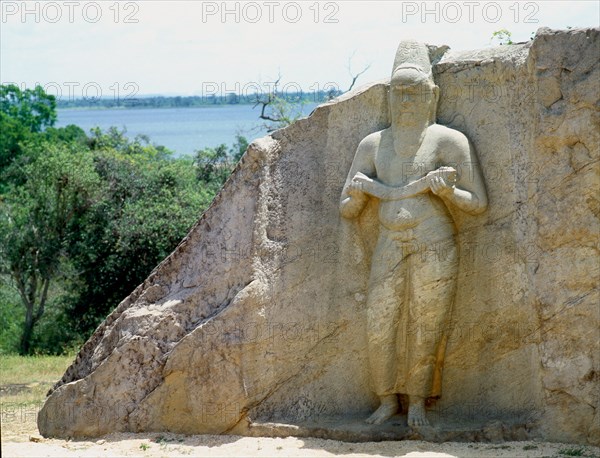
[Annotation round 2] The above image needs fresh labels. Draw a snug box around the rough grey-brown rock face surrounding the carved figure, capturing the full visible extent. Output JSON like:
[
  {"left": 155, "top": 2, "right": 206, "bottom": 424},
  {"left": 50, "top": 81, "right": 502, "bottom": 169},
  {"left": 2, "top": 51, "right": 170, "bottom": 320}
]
[{"left": 38, "top": 29, "right": 600, "bottom": 443}]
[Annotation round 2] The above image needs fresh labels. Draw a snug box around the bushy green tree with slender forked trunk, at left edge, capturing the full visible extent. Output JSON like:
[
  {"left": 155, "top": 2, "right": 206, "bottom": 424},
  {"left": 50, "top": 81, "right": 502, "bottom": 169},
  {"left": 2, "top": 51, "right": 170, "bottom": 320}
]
[{"left": 0, "top": 143, "right": 99, "bottom": 355}]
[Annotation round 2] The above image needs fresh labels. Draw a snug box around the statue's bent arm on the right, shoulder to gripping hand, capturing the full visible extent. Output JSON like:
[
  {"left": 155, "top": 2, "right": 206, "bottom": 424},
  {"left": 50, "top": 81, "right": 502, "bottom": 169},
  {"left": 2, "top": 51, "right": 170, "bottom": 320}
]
[{"left": 428, "top": 131, "right": 488, "bottom": 215}]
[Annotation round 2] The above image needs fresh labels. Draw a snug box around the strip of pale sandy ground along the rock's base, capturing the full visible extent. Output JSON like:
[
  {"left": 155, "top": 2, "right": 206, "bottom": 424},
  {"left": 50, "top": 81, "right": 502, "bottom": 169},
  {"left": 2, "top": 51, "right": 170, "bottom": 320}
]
[{"left": 2, "top": 434, "right": 600, "bottom": 458}]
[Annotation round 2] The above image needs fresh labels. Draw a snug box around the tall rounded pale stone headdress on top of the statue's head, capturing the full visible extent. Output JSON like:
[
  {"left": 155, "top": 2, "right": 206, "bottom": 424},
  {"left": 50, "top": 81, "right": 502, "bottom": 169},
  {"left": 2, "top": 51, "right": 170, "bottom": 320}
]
[{"left": 392, "top": 40, "right": 433, "bottom": 86}]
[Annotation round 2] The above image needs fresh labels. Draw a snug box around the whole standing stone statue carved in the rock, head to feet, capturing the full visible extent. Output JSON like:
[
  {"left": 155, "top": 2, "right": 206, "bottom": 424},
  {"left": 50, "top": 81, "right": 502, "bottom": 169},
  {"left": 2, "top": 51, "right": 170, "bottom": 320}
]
[{"left": 340, "top": 41, "right": 487, "bottom": 426}]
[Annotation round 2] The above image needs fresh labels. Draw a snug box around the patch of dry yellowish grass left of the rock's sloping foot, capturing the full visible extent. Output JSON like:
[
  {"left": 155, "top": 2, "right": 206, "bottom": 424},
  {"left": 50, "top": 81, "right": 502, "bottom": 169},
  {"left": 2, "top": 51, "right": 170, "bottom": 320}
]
[{"left": 0, "top": 355, "right": 74, "bottom": 440}]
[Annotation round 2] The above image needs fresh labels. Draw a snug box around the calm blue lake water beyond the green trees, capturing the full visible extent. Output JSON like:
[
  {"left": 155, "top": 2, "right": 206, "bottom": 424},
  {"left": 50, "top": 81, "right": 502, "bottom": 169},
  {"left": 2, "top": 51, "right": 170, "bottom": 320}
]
[{"left": 56, "top": 103, "right": 316, "bottom": 156}]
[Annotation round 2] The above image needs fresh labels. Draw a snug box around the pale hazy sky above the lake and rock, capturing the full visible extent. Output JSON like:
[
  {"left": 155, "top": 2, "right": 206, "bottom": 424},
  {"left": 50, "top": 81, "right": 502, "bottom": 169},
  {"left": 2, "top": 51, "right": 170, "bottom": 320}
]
[{"left": 0, "top": 0, "right": 600, "bottom": 98}]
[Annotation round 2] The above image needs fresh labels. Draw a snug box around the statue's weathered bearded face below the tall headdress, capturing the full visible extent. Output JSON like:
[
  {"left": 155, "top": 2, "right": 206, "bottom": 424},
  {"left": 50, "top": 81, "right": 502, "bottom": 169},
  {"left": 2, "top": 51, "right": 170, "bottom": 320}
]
[{"left": 390, "top": 84, "right": 437, "bottom": 126}]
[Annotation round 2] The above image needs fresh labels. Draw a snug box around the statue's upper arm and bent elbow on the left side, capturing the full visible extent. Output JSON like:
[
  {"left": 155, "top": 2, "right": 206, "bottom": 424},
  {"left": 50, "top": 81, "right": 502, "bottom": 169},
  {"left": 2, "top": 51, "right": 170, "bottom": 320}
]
[{"left": 340, "top": 137, "right": 376, "bottom": 218}]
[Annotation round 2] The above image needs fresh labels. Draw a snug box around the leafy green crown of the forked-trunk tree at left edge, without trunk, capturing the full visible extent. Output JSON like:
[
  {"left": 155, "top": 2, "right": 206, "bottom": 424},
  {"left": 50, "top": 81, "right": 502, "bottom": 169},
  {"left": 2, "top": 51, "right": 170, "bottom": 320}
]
[{"left": 0, "top": 143, "right": 99, "bottom": 282}]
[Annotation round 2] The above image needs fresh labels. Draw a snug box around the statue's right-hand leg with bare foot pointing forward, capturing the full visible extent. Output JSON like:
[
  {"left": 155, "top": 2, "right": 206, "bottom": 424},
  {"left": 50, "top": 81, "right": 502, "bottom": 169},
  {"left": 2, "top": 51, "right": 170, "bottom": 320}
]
[{"left": 403, "top": 238, "right": 458, "bottom": 426}]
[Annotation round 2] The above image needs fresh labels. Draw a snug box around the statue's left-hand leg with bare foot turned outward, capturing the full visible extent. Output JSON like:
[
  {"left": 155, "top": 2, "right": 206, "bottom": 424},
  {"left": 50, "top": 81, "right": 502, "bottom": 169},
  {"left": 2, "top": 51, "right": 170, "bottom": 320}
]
[{"left": 366, "top": 234, "right": 405, "bottom": 424}]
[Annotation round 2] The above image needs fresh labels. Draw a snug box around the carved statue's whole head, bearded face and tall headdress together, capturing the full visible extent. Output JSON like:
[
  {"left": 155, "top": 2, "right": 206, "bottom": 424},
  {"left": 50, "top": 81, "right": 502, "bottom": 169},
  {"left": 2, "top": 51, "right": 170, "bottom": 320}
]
[{"left": 390, "top": 41, "right": 439, "bottom": 127}]
